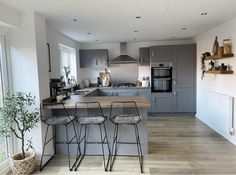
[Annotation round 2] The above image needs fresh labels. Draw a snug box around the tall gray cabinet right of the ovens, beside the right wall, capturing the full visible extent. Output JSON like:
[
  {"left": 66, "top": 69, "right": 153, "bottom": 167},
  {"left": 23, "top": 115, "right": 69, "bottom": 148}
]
[{"left": 173, "top": 44, "right": 196, "bottom": 113}]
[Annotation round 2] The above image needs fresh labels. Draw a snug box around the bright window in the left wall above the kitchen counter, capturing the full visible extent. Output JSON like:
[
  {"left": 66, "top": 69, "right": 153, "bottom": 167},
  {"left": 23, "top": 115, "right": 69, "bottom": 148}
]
[{"left": 59, "top": 44, "right": 77, "bottom": 84}]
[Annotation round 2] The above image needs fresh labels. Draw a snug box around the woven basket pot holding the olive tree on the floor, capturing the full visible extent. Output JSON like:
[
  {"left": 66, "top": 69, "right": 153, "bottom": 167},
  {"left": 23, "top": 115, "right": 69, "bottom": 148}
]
[{"left": 10, "top": 151, "right": 36, "bottom": 174}]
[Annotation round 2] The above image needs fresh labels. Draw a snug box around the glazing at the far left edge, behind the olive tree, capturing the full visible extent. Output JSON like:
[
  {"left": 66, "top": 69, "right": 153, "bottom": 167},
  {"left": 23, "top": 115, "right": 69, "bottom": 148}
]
[{"left": 0, "top": 35, "right": 9, "bottom": 165}]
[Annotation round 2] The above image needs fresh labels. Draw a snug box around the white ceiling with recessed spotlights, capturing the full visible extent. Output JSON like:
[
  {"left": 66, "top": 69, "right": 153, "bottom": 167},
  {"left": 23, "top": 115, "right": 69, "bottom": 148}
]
[{"left": 0, "top": 0, "right": 236, "bottom": 42}]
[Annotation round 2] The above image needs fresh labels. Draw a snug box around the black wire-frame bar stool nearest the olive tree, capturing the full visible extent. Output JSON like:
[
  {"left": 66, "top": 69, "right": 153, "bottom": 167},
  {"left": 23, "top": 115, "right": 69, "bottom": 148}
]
[{"left": 40, "top": 103, "right": 81, "bottom": 171}]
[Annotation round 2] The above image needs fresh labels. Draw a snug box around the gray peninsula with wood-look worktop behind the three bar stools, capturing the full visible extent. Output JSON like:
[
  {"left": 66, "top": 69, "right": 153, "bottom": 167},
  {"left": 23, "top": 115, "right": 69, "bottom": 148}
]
[{"left": 44, "top": 88, "right": 150, "bottom": 155}]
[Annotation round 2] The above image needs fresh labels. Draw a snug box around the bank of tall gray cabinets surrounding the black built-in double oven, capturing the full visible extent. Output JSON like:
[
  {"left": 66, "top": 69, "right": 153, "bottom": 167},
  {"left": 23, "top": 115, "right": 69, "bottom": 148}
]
[{"left": 150, "top": 44, "right": 196, "bottom": 113}]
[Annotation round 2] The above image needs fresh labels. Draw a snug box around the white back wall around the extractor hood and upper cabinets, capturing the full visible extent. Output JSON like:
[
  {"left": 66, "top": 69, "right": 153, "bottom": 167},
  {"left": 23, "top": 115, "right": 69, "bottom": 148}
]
[{"left": 79, "top": 40, "right": 193, "bottom": 83}]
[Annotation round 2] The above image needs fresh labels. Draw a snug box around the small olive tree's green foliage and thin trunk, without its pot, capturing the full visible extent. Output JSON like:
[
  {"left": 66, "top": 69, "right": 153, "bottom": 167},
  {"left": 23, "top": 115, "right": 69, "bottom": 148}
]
[{"left": 0, "top": 91, "right": 39, "bottom": 159}]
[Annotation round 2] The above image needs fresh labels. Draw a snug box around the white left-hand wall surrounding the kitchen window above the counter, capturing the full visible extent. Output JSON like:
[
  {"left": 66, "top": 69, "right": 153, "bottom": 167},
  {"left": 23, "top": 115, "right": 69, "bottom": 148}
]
[{"left": 46, "top": 25, "right": 79, "bottom": 81}]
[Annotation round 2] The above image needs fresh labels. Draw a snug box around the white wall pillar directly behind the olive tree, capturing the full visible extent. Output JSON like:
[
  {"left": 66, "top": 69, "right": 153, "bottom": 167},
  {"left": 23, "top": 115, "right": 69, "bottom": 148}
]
[{"left": 8, "top": 13, "right": 49, "bottom": 159}]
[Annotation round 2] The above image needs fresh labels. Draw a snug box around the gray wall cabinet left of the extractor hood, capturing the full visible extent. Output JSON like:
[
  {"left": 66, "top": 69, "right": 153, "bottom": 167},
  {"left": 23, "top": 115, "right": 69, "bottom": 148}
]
[{"left": 80, "top": 49, "right": 108, "bottom": 68}]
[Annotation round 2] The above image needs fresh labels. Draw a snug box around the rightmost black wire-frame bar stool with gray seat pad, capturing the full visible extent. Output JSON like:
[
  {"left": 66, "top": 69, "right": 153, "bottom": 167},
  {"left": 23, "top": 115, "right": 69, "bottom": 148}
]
[{"left": 110, "top": 101, "right": 143, "bottom": 173}]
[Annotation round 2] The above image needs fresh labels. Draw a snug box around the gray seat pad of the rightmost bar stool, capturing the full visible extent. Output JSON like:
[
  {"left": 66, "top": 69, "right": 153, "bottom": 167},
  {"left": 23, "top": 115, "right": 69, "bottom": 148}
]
[{"left": 111, "top": 114, "right": 141, "bottom": 124}]
